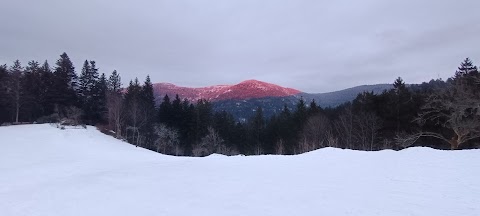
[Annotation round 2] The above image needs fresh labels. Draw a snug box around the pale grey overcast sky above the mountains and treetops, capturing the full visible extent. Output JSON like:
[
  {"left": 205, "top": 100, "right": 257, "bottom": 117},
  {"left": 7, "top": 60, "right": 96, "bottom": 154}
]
[{"left": 0, "top": 0, "right": 480, "bottom": 93}]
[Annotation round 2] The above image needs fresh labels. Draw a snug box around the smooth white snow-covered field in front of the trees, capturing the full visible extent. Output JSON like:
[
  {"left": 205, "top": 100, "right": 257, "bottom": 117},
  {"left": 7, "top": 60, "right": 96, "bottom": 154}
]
[{"left": 0, "top": 125, "right": 480, "bottom": 216}]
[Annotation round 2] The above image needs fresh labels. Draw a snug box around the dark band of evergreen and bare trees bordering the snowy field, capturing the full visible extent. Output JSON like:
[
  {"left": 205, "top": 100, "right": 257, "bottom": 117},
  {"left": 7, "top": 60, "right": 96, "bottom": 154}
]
[{"left": 0, "top": 53, "right": 480, "bottom": 156}]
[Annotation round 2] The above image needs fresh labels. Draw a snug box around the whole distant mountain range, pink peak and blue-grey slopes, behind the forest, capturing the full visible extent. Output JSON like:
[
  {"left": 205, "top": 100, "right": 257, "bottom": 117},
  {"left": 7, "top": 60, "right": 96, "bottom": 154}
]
[{"left": 153, "top": 80, "right": 393, "bottom": 121}]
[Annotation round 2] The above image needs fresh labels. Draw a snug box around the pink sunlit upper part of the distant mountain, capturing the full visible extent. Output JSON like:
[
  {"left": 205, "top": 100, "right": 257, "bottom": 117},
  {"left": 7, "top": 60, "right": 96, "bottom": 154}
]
[{"left": 153, "top": 80, "right": 301, "bottom": 101}]
